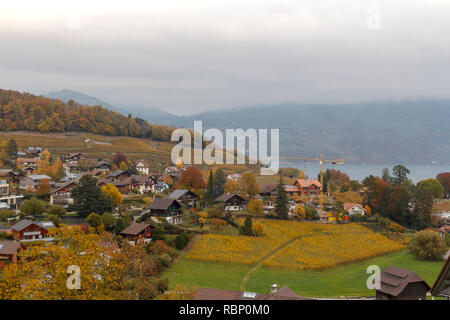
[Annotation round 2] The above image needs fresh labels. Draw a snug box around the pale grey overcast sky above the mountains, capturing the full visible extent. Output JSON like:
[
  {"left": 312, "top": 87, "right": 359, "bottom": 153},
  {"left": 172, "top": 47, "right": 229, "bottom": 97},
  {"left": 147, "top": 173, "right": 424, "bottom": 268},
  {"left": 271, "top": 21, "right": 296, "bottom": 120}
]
[{"left": 0, "top": 0, "right": 450, "bottom": 114}]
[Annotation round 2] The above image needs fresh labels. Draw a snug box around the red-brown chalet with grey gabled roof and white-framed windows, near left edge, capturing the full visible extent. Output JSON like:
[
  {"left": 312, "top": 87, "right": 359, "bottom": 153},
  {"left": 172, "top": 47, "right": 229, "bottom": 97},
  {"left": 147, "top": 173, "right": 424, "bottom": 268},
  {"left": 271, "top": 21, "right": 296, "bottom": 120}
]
[{"left": 11, "top": 219, "right": 55, "bottom": 242}]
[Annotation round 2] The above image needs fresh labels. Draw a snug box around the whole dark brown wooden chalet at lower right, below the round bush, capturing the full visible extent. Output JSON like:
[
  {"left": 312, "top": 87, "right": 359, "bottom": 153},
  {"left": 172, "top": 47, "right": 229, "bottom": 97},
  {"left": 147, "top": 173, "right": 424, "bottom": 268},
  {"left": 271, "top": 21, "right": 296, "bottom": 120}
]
[{"left": 376, "top": 266, "right": 430, "bottom": 300}]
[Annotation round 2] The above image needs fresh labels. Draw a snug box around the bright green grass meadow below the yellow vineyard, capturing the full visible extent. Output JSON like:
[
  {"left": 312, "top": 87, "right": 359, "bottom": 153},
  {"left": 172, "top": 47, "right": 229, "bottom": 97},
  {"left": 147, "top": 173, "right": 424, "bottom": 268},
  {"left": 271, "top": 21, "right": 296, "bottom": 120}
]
[{"left": 162, "top": 250, "right": 444, "bottom": 297}]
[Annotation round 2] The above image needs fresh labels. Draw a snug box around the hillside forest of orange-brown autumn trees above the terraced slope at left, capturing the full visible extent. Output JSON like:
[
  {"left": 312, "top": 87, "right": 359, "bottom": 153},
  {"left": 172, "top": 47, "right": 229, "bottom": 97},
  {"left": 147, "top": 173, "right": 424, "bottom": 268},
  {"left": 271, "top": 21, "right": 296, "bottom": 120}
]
[{"left": 0, "top": 89, "right": 173, "bottom": 141}]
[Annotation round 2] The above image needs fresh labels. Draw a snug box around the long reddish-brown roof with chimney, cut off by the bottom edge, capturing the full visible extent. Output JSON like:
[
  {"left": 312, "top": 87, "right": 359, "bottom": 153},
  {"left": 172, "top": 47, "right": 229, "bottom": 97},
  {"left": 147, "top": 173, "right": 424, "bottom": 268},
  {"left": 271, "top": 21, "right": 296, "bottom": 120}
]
[{"left": 194, "top": 284, "right": 314, "bottom": 301}]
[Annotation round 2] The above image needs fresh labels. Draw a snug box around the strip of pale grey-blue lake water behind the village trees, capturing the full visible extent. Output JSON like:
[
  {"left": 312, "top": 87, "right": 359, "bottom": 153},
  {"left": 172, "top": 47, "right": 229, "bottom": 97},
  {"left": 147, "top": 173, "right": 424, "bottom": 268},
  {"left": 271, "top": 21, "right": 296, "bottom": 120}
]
[{"left": 280, "top": 161, "right": 450, "bottom": 183}]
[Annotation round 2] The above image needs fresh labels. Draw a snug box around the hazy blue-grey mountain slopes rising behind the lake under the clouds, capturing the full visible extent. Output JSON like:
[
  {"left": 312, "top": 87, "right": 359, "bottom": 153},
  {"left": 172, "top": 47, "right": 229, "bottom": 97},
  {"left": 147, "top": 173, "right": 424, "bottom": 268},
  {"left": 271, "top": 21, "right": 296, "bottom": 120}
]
[{"left": 41, "top": 90, "right": 450, "bottom": 164}]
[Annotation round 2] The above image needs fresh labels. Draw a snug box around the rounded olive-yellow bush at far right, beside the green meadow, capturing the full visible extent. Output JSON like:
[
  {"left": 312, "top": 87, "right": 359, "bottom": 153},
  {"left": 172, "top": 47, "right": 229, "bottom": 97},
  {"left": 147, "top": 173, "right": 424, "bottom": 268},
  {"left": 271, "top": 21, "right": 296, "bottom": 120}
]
[{"left": 409, "top": 231, "right": 447, "bottom": 261}]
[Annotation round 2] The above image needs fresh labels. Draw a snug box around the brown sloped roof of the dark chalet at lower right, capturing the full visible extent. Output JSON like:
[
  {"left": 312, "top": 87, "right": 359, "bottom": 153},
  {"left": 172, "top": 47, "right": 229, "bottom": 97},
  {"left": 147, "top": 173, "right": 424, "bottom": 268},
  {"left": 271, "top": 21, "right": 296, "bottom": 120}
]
[{"left": 378, "top": 266, "right": 430, "bottom": 296}]
